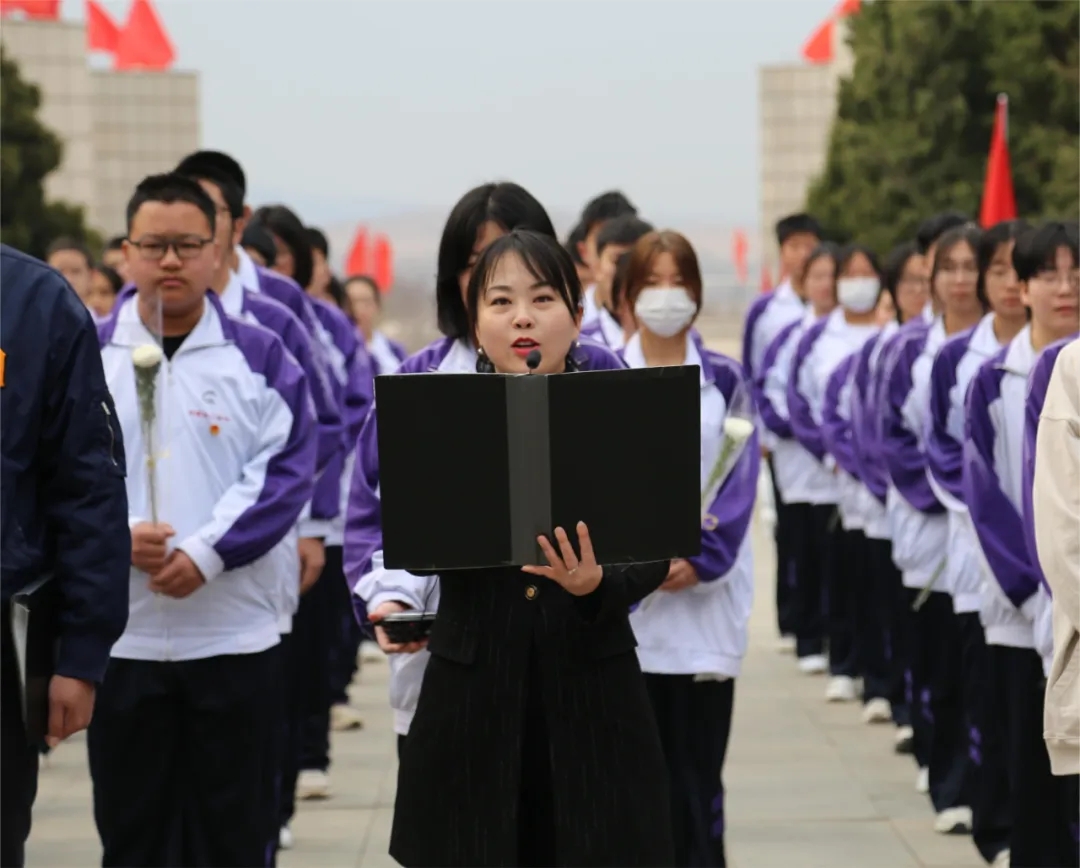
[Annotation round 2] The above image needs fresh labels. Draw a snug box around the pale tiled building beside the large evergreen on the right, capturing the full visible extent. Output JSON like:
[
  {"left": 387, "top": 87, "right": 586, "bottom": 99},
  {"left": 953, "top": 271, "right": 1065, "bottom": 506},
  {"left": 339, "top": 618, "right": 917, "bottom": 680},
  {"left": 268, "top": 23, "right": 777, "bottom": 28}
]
[{"left": 758, "top": 22, "right": 852, "bottom": 279}]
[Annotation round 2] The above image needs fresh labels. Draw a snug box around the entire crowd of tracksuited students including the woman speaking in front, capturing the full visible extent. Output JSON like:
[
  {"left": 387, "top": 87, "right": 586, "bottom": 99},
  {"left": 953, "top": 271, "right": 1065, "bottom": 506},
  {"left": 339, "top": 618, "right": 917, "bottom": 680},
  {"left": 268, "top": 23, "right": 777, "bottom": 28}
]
[{"left": 6, "top": 143, "right": 1080, "bottom": 866}]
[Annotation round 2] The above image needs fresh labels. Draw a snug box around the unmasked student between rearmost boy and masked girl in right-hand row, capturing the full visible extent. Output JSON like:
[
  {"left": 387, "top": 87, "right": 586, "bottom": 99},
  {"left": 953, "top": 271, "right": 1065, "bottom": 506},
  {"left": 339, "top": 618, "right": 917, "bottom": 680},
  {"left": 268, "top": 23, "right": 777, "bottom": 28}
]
[{"left": 756, "top": 243, "right": 839, "bottom": 675}]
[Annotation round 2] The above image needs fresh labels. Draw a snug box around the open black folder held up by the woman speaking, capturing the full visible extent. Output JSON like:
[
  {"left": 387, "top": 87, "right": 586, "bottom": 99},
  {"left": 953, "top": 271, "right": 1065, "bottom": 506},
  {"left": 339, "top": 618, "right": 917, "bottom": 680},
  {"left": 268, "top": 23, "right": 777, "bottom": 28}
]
[{"left": 375, "top": 367, "right": 701, "bottom": 572}]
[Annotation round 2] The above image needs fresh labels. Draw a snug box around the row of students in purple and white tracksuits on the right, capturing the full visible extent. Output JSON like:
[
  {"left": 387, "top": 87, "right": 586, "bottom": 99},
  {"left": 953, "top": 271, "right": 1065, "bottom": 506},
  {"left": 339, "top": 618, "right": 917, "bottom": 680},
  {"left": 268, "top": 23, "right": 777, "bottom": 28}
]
[{"left": 743, "top": 213, "right": 1080, "bottom": 866}]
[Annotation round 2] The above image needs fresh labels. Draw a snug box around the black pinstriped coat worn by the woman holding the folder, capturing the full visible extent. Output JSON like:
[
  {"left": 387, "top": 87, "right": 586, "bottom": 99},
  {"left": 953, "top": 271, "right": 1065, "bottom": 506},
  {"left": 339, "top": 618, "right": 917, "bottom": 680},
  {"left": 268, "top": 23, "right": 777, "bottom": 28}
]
[{"left": 390, "top": 561, "right": 673, "bottom": 868}]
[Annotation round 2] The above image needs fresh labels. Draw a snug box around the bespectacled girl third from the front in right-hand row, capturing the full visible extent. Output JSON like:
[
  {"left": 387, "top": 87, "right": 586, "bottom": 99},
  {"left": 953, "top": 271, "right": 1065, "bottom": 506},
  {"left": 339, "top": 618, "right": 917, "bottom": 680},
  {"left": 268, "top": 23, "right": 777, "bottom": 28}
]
[{"left": 879, "top": 223, "right": 984, "bottom": 833}]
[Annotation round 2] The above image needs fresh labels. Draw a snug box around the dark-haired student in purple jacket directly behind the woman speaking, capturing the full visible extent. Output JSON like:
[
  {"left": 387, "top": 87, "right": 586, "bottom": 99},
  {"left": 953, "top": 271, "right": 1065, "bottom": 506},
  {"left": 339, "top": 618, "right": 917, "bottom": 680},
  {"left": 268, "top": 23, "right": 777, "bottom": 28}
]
[{"left": 345, "top": 182, "right": 622, "bottom": 747}]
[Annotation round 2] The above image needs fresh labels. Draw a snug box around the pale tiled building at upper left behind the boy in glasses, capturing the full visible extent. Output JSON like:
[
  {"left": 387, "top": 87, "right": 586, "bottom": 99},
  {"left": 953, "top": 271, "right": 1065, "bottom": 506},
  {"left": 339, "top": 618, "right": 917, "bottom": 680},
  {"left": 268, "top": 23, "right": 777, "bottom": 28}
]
[{"left": 0, "top": 18, "right": 200, "bottom": 236}]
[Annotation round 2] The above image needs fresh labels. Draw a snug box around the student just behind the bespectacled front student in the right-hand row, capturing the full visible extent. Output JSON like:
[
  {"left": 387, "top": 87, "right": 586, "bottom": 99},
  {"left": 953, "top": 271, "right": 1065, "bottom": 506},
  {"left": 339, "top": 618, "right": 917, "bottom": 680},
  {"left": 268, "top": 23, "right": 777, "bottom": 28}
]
[{"left": 927, "top": 221, "right": 1026, "bottom": 862}]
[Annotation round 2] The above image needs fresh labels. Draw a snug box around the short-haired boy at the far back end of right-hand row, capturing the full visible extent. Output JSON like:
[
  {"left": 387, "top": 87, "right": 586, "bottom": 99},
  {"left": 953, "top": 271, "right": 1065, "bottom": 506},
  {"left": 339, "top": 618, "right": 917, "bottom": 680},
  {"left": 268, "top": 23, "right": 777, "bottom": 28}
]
[{"left": 742, "top": 214, "right": 816, "bottom": 651}]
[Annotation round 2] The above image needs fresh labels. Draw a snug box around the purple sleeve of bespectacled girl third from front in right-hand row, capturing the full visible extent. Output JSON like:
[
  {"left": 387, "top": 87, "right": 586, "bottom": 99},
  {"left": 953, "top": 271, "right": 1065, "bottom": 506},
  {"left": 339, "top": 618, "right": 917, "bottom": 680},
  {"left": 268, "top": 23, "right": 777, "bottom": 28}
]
[{"left": 880, "top": 333, "right": 945, "bottom": 515}]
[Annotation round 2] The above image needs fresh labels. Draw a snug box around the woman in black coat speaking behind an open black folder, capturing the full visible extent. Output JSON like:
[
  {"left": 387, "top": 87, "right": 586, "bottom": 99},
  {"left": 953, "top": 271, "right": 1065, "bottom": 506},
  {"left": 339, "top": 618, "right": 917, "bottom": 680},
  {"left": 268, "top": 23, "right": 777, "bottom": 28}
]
[{"left": 350, "top": 230, "right": 672, "bottom": 866}]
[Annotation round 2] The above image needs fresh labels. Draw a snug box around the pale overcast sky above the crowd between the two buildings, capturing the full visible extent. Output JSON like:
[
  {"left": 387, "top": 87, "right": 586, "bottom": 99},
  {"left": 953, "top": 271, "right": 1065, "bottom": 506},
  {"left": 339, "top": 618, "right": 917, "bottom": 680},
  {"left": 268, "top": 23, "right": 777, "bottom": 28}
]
[{"left": 76, "top": 0, "right": 834, "bottom": 223}]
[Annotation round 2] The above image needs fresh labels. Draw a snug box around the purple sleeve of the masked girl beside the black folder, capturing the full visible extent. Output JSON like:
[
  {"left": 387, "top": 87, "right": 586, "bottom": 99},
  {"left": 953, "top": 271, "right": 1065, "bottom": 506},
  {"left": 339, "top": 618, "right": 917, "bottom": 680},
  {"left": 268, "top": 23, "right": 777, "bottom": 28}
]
[{"left": 688, "top": 353, "right": 761, "bottom": 582}]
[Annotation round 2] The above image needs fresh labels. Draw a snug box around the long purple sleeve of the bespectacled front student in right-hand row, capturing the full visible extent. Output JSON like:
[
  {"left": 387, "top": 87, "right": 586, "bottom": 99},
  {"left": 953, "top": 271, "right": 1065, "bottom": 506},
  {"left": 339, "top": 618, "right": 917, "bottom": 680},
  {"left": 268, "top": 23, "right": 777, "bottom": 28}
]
[{"left": 963, "top": 362, "right": 1039, "bottom": 609}]
